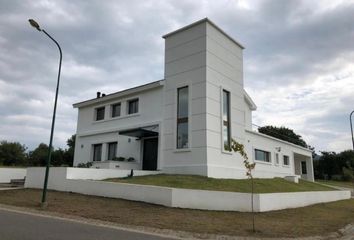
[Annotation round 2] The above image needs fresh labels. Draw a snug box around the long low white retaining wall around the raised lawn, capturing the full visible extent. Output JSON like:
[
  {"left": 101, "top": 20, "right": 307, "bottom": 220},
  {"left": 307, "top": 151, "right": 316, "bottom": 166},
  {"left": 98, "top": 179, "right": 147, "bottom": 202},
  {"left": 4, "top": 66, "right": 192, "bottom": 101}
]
[{"left": 25, "top": 168, "right": 351, "bottom": 212}]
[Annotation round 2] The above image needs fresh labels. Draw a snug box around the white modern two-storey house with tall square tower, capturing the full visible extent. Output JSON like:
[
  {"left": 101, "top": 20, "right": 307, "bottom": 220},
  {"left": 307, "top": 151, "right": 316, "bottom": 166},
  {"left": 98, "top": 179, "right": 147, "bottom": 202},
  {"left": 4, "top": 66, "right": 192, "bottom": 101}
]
[{"left": 73, "top": 19, "right": 314, "bottom": 181}]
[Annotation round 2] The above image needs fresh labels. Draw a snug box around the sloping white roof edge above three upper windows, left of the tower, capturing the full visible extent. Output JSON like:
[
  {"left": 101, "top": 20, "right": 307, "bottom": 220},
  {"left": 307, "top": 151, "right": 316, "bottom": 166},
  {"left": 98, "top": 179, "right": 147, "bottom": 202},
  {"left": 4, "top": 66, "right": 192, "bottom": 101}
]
[{"left": 73, "top": 79, "right": 164, "bottom": 108}]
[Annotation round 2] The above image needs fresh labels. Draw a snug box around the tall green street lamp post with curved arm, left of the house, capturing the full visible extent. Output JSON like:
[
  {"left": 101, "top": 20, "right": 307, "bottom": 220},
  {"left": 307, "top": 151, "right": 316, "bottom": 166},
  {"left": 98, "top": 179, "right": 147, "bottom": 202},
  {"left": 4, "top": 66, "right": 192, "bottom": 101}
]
[{"left": 28, "top": 19, "right": 62, "bottom": 208}]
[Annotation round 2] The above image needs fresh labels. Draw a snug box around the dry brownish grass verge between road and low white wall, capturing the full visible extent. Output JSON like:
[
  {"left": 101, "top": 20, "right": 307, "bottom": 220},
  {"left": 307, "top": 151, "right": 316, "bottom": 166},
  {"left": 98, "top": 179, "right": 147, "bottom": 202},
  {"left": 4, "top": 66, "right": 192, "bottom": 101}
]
[{"left": 0, "top": 189, "right": 354, "bottom": 237}]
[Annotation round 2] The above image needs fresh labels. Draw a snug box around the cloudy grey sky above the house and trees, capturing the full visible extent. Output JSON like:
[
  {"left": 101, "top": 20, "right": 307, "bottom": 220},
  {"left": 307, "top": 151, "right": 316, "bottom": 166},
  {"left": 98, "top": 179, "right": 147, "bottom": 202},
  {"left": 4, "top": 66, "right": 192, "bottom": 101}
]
[{"left": 0, "top": 0, "right": 354, "bottom": 151}]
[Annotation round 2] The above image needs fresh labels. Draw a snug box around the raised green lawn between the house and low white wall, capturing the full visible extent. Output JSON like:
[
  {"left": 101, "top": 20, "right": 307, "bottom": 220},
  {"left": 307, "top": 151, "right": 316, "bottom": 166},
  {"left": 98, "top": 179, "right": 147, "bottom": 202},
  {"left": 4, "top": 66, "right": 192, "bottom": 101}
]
[{"left": 104, "top": 174, "right": 334, "bottom": 193}]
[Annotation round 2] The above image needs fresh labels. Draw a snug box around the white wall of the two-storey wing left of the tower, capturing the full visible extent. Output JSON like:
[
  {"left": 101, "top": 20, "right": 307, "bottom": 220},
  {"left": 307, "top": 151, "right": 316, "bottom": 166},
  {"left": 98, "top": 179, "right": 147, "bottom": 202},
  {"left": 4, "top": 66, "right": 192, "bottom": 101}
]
[{"left": 74, "top": 87, "right": 162, "bottom": 168}]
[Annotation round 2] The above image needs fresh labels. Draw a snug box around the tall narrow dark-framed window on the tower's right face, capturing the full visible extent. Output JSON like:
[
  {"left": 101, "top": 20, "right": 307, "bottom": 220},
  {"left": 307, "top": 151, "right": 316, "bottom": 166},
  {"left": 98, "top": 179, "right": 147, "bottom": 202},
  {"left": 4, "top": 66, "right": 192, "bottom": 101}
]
[{"left": 222, "top": 89, "right": 231, "bottom": 150}]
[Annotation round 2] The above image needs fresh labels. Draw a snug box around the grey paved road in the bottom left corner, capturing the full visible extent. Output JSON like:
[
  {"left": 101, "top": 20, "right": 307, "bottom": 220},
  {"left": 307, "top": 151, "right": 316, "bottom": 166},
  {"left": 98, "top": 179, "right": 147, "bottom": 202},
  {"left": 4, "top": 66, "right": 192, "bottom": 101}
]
[{"left": 0, "top": 210, "right": 177, "bottom": 240}]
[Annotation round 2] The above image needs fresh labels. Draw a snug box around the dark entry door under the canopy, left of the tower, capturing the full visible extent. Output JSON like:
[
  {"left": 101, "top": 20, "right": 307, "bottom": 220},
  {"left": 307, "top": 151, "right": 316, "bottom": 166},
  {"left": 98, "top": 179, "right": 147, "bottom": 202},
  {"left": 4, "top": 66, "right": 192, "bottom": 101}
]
[{"left": 143, "top": 138, "right": 158, "bottom": 170}]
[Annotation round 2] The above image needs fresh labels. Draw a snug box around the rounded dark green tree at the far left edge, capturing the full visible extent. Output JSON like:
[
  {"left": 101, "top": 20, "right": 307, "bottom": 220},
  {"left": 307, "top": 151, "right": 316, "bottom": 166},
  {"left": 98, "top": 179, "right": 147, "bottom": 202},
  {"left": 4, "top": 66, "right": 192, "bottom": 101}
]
[{"left": 0, "top": 141, "right": 27, "bottom": 166}]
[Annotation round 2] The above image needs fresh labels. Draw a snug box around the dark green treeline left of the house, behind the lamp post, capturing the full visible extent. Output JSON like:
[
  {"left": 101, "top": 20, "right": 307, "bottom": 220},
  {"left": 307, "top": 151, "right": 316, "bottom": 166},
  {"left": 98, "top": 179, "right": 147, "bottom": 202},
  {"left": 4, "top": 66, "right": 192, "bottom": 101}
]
[{"left": 0, "top": 135, "right": 76, "bottom": 167}]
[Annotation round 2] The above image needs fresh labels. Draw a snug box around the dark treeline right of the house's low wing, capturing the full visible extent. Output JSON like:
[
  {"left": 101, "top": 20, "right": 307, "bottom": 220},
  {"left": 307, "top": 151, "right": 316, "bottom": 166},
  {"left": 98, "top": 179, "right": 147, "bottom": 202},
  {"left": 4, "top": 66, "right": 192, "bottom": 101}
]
[{"left": 313, "top": 150, "right": 354, "bottom": 181}]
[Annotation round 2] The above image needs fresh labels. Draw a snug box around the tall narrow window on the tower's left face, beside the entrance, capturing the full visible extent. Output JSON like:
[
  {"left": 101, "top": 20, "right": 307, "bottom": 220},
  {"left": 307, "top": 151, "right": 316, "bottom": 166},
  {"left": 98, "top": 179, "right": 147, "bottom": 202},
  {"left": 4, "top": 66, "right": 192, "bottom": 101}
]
[{"left": 177, "top": 87, "right": 189, "bottom": 149}]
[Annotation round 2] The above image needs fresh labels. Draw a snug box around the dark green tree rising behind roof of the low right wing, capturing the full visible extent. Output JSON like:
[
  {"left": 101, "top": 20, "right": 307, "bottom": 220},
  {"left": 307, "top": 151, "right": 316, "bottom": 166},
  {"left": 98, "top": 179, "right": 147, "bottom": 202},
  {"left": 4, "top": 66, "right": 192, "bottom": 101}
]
[{"left": 258, "top": 126, "right": 308, "bottom": 148}]
